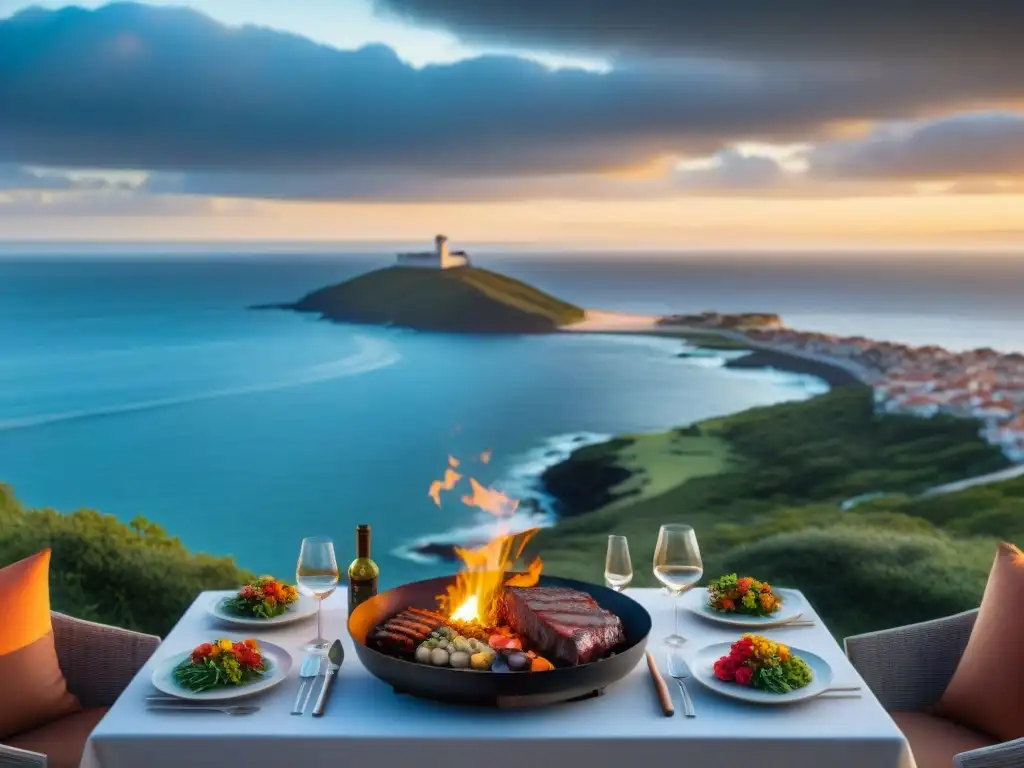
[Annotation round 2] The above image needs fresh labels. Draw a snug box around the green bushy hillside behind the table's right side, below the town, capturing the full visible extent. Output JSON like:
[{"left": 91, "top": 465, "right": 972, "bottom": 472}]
[{"left": 536, "top": 386, "right": 1007, "bottom": 635}]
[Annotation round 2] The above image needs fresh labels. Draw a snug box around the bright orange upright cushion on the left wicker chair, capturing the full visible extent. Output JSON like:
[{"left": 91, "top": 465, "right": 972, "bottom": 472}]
[{"left": 0, "top": 550, "right": 81, "bottom": 738}]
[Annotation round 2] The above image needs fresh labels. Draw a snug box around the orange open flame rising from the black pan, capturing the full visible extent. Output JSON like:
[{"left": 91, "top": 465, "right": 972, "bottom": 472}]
[{"left": 428, "top": 451, "right": 543, "bottom": 626}]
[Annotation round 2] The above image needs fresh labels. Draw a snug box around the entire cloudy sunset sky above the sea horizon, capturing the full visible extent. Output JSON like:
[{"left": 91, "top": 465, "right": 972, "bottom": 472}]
[{"left": 0, "top": 0, "right": 1024, "bottom": 250}]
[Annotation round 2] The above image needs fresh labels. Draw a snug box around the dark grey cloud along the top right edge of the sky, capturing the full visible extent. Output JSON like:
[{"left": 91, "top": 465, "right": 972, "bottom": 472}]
[{"left": 375, "top": 0, "right": 1024, "bottom": 72}]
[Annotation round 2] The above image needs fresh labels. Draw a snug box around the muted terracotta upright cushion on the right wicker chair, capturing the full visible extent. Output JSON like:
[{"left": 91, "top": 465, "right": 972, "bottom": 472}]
[{"left": 935, "top": 544, "right": 1024, "bottom": 741}]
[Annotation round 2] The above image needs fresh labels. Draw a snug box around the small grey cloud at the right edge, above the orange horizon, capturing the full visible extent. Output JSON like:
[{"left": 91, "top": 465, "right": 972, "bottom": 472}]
[{"left": 807, "top": 113, "right": 1024, "bottom": 180}]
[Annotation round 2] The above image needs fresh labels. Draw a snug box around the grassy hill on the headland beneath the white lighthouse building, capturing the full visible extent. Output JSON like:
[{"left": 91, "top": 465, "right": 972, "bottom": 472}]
[{"left": 294, "top": 266, "right": 584, "bottom": 333}]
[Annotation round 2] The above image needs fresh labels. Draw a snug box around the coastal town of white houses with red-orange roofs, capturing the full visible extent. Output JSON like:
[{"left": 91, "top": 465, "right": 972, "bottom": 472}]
[{"left": 734, "top": 327, "right": 1024, "bottom": 462}]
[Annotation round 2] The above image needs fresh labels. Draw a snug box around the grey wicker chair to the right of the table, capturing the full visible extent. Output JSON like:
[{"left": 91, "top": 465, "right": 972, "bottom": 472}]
[{"left": 844, "top": 610, "right": 1024, "bottom": 768}]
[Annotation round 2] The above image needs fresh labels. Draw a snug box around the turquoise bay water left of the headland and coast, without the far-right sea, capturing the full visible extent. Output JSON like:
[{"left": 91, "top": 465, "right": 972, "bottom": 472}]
[{"left": 0, "top": 256, "right": 821, "bottom": 583}]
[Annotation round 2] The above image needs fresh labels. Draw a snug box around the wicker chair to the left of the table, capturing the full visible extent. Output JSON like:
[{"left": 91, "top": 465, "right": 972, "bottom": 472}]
[{"left": 0, "top": 613, "right": 160, "bottom": 768}]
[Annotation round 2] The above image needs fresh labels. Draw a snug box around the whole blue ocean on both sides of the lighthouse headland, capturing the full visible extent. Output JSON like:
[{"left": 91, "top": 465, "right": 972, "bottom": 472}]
[{"left": 0, "top": 253, "right": 1024, "bottom": 587}]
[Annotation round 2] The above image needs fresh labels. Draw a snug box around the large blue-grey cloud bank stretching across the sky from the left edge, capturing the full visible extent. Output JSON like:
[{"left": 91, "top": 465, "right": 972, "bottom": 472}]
[{"left": 0, "top": 4, "right": 1024, "bottom": 188}]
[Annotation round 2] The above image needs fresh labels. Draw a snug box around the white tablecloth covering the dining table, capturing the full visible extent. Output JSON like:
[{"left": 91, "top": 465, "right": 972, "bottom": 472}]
[{"left": 82, "top": 589, "right": 913, "bottom": 768}]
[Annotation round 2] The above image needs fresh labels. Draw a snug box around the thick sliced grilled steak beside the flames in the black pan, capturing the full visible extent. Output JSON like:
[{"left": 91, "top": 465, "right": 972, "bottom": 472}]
[{"left": 501, "top": 587, "right": 626, "bottom": 665}]
